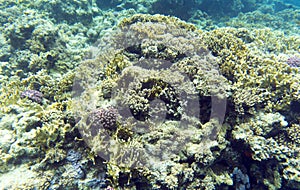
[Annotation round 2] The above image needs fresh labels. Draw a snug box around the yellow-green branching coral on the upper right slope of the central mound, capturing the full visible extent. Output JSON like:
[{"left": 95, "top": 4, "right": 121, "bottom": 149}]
[{"left": 205, "top": 28, "right": 300, "bottom": 114}]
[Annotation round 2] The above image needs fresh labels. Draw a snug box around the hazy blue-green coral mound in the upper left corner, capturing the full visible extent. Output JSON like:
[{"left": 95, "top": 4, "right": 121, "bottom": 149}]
[{"left": 1, "top": 9, "right": 87, "bottom": 77}]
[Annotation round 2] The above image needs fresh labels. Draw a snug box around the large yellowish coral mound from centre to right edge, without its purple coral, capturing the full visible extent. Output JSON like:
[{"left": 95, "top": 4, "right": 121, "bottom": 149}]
[{"left": 71, "top": 15, "right": 299, "bottom": 189}]
